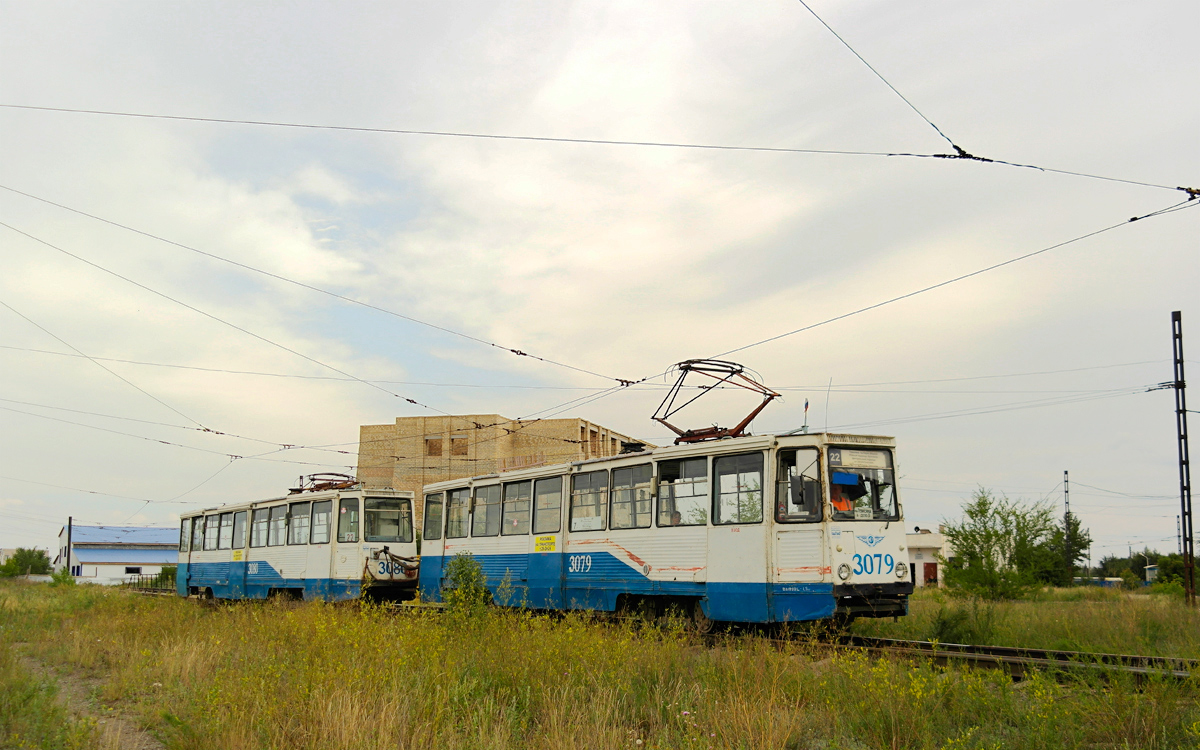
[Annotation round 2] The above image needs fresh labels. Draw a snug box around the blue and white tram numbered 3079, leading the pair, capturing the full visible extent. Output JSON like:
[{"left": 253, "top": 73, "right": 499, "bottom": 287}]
[{"left": 420, "top": 434, "right": 913, "bottom": 629}]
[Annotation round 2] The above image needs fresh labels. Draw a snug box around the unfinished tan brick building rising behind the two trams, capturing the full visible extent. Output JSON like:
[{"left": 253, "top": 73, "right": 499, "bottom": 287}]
[{"left": 358, "top": 414, "right": 649, "bottom": 528}]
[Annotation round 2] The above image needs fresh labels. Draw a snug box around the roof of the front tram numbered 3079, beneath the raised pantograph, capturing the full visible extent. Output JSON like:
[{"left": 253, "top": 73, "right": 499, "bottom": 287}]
[{"left": 425, "top": 432, "right": 895, "bottom": 492}]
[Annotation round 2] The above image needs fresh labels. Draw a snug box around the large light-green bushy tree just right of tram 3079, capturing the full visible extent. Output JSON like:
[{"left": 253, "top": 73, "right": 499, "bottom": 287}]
[{"left": 943, "top": 487, "right": 1055, "bottom": 599}]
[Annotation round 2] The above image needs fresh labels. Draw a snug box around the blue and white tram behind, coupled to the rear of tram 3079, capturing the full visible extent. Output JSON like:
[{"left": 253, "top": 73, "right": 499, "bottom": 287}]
[{"left": 175, "top": 487, "right": 418, "bottom": 601}]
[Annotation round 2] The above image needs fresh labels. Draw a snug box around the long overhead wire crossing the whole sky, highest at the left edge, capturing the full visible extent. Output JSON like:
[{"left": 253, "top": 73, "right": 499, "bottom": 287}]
[{"left": 0, "top": 103, "right": 1180, "bottom": 196}]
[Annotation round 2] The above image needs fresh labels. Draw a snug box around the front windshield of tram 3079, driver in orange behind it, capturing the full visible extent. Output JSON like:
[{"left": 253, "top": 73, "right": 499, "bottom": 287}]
[{"left": 829, "top": 448, "right": 900, "bottom": 521}]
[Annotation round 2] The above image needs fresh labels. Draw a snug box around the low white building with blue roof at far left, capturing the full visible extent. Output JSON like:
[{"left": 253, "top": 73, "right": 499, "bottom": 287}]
[{"left": 54, "top": 526, "right": 179, "bottom": 586}]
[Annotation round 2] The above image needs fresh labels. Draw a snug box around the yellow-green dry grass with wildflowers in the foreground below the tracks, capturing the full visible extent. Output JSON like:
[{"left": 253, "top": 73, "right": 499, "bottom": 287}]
[{"left": 0, "top": 578, "right": 1200, "bottom": 750}]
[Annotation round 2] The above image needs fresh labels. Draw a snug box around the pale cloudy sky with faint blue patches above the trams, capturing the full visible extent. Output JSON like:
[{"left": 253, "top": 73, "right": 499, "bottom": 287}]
[{"left": 0, "top": 0, "right": 1200, "bottom": 558}]
